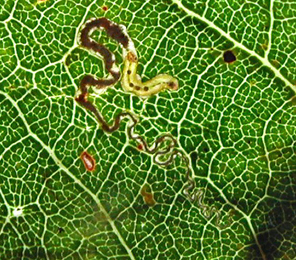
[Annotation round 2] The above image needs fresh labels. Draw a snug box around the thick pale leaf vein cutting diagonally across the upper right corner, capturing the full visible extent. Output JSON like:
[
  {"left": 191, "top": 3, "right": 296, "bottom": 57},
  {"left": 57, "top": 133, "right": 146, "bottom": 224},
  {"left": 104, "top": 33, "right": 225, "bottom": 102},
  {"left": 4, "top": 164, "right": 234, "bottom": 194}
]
[{"left": 172, "top": 0, "right": 296, "bottom": 93}]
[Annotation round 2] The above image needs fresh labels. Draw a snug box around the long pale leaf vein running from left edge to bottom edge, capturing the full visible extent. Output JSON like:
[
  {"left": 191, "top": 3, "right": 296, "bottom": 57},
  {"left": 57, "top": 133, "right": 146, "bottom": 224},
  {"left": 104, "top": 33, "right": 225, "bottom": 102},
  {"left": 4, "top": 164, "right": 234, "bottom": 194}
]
[{"left": 0, "top": 90, "right": 135, "bottom": 260}]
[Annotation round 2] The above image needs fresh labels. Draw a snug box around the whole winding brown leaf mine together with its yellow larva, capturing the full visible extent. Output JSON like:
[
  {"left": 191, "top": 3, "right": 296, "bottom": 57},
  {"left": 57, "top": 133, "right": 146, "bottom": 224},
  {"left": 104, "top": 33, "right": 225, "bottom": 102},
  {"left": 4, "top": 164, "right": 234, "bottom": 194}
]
[{"left": 75, "top": 18, "right": 221, "bottom": 227}]
